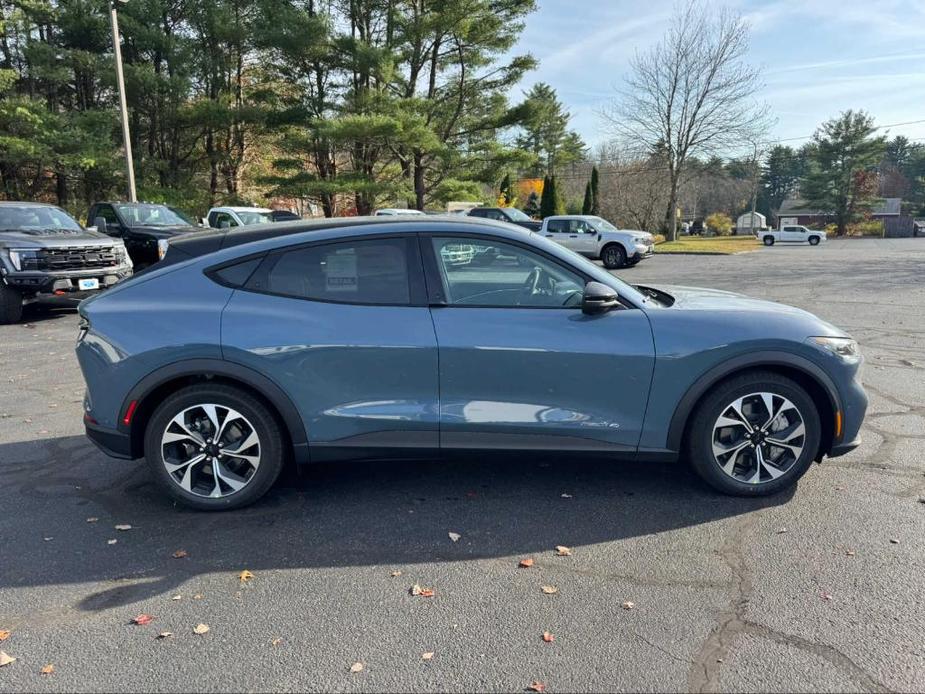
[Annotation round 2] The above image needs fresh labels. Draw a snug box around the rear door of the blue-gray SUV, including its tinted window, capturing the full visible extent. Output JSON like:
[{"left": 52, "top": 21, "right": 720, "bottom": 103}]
[{"left": 222, "top": 235, "right": 439, "bottom": 460}]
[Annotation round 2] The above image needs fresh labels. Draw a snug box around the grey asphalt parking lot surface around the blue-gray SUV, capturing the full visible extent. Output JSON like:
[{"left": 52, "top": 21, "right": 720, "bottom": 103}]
[{"left": 0, "top": 239, "right": 925, "bottom": 692}]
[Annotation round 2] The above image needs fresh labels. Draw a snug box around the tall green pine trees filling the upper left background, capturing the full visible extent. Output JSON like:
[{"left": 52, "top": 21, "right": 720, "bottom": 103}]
[{"left": 0, "top": 0, "right": 585, "bottom": 216}]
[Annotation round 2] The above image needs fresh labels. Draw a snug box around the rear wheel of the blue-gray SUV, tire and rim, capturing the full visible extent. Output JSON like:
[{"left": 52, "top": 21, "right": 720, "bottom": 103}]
[{"left": 144, "top": 385, "right": 284, "bottom": 511}]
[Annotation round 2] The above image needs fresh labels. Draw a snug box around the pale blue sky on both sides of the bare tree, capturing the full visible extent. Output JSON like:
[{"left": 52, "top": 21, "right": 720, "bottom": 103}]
[{"left": 508, "top": 0, "right": 925, "bottom": 155}]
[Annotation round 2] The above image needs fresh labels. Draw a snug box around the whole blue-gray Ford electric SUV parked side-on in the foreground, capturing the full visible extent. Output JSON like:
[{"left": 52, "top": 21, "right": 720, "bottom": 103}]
[{"left": 77, "top": 217, "right": 867, "bottom": 509}]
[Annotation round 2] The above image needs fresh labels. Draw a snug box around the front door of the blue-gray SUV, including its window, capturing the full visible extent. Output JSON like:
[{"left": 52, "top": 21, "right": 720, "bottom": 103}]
[{"left": 422, "top": 234, "right": 654, "bottom": 453}]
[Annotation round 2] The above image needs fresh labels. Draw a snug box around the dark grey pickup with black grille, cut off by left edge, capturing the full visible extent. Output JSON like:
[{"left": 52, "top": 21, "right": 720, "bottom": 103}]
[{"left": 0, "top": 202, "right": 132, "bottom": 323}]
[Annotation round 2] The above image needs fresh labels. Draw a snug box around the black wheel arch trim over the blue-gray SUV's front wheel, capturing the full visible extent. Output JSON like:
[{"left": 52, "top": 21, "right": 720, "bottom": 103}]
[{"left": 667, "top": 351, "right": 842, "bottom": 451}]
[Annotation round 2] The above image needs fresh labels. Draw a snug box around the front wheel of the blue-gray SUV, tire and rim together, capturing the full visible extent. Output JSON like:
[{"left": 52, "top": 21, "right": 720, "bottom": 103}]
[{"left": 686, "top": 371, "right": 822, "bottom": 497}]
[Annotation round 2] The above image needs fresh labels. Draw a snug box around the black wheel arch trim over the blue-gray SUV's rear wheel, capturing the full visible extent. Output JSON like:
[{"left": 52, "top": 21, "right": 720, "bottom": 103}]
[{"left": 119, "top": 359, "right": 308, "bottom": 463}]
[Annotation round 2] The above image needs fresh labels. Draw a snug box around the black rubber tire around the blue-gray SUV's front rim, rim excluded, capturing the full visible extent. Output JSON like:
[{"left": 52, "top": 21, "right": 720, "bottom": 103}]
[{"left": 688, "top": 374, "right": 821, "bottom": 496}]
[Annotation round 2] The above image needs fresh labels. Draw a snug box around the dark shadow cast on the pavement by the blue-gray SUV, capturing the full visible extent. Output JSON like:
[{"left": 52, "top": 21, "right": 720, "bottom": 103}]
[{"left": 0, "top": 436, "right": 791, "bottom": 611}]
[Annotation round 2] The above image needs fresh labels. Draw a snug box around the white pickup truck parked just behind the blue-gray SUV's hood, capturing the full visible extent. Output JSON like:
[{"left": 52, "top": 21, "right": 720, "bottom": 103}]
[{"left": 536, "top": 214, "right": 655, "bottom": 270}]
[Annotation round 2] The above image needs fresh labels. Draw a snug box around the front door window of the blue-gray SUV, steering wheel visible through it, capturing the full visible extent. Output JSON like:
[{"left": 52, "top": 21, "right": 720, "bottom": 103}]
[{"left": 431, "top": 238, "right": 584, "bottom": 308}]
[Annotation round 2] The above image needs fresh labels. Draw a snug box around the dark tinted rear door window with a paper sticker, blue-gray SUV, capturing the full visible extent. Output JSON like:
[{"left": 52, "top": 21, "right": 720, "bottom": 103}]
[{"left": 260, "top": 238, "right": 411, "bottom": 304}]
